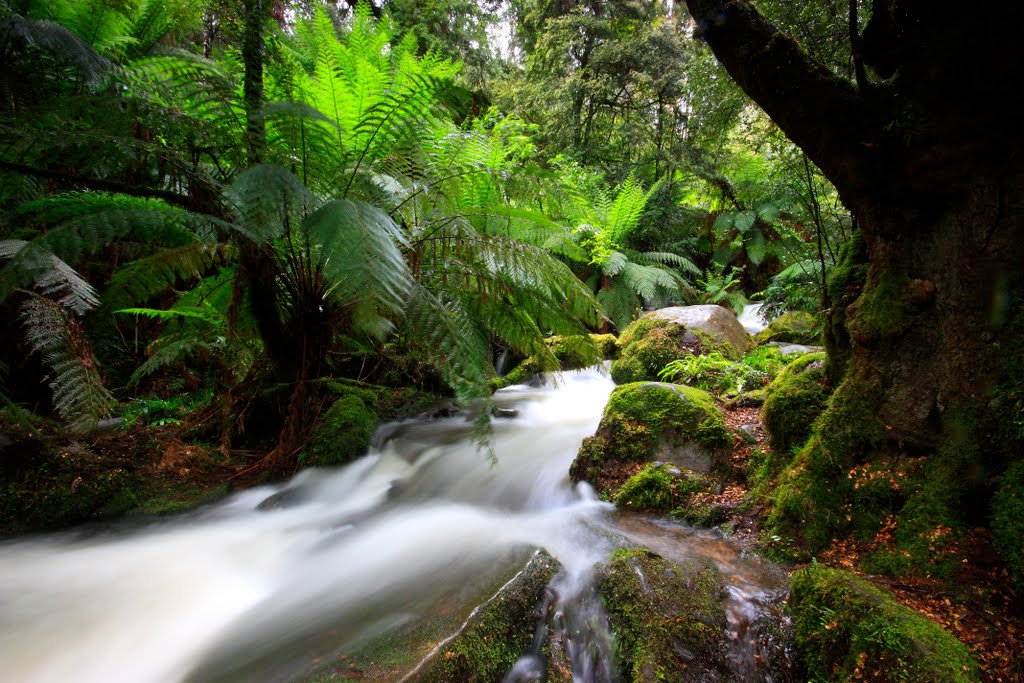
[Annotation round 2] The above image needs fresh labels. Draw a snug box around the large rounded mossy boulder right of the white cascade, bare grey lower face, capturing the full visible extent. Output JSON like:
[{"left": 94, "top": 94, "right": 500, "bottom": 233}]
[{"left": 569, "top": 382, "right": 732, "bottom": 497}]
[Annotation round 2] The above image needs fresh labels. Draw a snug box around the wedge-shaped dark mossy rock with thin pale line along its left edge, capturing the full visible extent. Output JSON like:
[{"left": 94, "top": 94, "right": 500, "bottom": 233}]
[{"left": 408, "top": 551, "right": 560, "bottom": 683}]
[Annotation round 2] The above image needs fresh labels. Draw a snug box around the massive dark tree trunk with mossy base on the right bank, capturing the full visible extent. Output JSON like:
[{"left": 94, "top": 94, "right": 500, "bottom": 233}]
[{"left": 687, "top": 0, "right": 1024, "bottom": 547}]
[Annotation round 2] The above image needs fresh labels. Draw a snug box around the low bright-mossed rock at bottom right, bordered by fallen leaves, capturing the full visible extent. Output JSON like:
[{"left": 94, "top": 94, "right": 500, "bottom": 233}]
[{"left": 790, "top": 564, "right": 980, "bottom": 683}]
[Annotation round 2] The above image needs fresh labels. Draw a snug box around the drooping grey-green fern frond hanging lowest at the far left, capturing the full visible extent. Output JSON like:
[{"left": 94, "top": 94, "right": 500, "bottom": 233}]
[{"left": 20, "top": 294, "right": 116, "bottom": 431}]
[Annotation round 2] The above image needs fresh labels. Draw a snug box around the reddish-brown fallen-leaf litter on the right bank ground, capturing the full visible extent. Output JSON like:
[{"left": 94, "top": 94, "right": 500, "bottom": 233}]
[{"left": 716, "top": 407, "right": 1024, "bottom": 683}]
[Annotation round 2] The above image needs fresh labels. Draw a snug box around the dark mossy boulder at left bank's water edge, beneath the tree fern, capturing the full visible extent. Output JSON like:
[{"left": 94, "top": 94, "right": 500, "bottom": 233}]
[{"left": 299, "top": 380, "right": 436, "bottom": 467}]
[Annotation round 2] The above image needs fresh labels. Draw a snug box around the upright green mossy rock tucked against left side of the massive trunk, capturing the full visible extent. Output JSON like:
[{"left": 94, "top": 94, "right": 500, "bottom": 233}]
[{"left": 762, "top": 353, "right": 831, "bottom": 457}]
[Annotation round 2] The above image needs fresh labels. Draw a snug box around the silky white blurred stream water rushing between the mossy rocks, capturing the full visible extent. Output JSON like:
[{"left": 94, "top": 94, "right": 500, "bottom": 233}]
[{"left": 0, "top": 369, "right": 779, "bottom": 683}]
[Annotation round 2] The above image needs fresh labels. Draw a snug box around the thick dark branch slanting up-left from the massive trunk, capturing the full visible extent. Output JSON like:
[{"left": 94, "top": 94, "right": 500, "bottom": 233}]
[{"left": 686, "top": 0, "right": 876, "bottom": 202}]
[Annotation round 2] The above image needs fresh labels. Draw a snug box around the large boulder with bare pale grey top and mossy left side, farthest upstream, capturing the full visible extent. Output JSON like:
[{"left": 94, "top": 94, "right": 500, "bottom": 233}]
[{"left": 611, "top": 305, "right": 753, "bottom": 384}]
